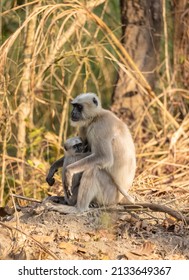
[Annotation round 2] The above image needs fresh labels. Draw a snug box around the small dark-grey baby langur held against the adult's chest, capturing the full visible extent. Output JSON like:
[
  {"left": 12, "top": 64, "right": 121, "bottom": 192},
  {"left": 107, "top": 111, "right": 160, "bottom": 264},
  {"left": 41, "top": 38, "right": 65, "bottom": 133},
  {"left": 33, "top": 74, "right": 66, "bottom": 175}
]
[{"left": 46, "top": 137, "right": 90, "bottom": 205}]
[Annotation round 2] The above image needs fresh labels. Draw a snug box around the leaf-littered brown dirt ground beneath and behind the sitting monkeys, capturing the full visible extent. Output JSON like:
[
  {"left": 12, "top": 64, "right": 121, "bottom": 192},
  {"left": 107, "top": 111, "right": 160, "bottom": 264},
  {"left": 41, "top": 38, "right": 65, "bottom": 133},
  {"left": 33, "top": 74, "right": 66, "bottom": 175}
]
[{"left": 0, "top": 186, "right": 189, "bottom": 260}]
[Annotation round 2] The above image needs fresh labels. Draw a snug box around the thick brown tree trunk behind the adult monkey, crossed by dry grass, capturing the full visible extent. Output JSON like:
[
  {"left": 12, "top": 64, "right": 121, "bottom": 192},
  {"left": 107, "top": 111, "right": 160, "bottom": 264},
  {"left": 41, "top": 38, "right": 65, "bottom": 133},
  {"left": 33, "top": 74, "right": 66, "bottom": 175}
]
[{"left": 112, "top": 0, "right": 161, "bottom": 124}]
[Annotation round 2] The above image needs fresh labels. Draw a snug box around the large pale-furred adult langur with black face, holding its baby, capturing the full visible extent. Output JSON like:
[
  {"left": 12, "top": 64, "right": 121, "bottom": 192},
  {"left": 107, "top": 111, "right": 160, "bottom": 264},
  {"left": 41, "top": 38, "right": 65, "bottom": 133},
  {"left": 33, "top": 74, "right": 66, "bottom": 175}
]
[{"left": 47, "top": 93, "right": 136, "bottom": 213}]
